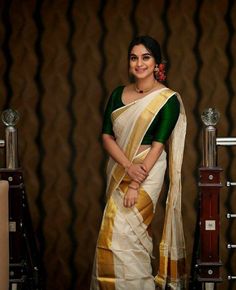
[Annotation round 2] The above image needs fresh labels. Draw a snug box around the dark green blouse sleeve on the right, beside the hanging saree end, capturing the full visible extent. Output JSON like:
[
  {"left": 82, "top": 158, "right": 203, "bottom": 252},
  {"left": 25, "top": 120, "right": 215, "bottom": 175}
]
[{"left": 154, "top": 95, "right": 180, "bottom": 144}]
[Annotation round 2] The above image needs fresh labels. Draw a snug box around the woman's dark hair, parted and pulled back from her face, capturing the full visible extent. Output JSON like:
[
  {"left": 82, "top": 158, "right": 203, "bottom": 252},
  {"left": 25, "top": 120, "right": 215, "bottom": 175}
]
[{"left": 128, "top": 35, "right": 162, "bottom": 64}]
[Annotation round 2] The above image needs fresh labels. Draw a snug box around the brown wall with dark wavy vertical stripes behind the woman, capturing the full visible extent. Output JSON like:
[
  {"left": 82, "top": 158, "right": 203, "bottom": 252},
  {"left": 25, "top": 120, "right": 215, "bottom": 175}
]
[{"left": 0, "top": 0, "right": 236, "bottom": 290}]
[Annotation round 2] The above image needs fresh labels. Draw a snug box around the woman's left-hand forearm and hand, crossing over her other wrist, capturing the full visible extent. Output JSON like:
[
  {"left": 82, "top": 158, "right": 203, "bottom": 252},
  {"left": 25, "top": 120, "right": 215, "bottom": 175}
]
[{"left": 102, "top": 134, "right": 147, "bottom": 183}]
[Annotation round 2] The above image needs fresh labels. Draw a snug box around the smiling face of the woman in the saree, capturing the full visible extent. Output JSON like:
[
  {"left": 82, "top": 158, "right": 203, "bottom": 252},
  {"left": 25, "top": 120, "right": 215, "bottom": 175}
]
[{"left": 129, "top": 44, "right": 156, "bottom": 79}]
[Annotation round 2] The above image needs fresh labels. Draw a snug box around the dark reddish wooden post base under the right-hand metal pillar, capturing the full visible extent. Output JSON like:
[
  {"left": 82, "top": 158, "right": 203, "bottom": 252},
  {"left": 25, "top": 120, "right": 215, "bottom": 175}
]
[{"left": 196, "top": 167, "right": 222, "bottom": 283}]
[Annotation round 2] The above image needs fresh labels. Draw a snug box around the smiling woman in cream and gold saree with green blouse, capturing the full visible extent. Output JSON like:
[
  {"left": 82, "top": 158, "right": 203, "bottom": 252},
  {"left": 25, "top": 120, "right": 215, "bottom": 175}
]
[{"left": 91, "top": 36, "right": 186, "bottom": 290}]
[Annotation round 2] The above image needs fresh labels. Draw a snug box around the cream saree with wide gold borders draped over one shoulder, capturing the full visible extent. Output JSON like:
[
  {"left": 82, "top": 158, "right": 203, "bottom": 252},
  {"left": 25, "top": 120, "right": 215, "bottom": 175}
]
[{"left": 90, "top": 88, "right": 186, "bottom": 290}]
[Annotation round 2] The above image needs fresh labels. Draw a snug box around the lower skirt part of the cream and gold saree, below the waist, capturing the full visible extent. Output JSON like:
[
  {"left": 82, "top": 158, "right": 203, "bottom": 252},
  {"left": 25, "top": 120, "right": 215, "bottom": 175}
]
[{"left": 91, "top": 151, "right": 166, "bottom": 290}]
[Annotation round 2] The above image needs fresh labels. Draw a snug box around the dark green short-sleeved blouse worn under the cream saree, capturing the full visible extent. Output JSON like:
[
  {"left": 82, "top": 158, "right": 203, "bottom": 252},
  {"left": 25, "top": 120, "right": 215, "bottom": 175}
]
[{"left": 102, "top": 86, "right": 180, "bottom": 145}]
